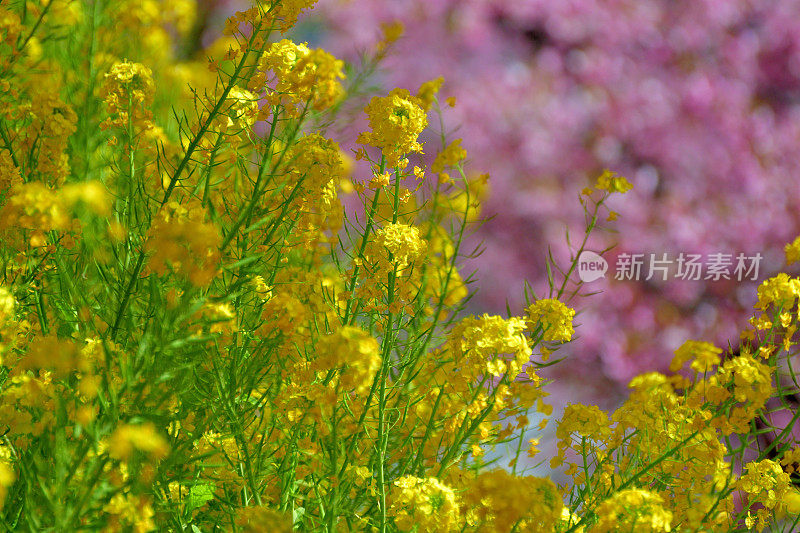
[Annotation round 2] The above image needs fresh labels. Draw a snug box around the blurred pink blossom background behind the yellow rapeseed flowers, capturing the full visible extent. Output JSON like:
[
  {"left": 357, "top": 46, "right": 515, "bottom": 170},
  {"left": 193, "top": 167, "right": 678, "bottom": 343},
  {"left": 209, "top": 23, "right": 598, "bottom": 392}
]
[{"left": 197, "top": 0, "right": 800, "bottom": 407}]
